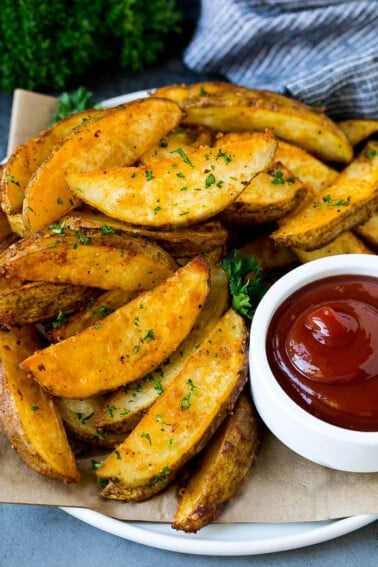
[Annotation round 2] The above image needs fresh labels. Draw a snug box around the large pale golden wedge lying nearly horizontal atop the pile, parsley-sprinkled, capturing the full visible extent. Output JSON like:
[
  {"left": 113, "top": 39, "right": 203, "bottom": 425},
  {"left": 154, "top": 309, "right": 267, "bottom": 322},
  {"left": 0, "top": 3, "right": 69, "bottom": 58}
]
[{"left": 67, "top": 134, "right": 276, "bottom": 227}]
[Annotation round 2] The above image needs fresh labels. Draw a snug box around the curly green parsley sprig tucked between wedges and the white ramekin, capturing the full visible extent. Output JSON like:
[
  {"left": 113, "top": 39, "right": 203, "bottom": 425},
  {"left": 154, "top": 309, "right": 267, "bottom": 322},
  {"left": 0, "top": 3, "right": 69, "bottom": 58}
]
[{"left": 221, "top": 250, "right": 266, "bottom": 319}]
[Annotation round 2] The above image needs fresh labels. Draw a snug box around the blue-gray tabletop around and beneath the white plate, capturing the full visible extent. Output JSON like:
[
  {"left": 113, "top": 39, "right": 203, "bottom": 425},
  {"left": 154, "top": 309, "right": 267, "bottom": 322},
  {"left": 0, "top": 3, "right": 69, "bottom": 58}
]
[{"left": 0, "top": 3, "right": 378, "bottom": 567}]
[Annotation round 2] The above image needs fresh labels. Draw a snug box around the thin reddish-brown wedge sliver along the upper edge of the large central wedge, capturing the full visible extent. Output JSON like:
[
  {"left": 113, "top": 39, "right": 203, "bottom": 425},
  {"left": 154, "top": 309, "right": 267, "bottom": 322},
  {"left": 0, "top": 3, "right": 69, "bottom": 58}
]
[{"left": 47, "top": 286, "right": 138, "bottom": 343}]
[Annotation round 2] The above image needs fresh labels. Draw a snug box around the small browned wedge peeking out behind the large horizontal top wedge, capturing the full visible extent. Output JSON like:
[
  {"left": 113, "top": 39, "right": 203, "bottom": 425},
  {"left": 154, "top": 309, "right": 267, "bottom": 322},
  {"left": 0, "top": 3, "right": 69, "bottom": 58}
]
[{"left": 139, "top": 126, "right": 215, "bottom": 165}]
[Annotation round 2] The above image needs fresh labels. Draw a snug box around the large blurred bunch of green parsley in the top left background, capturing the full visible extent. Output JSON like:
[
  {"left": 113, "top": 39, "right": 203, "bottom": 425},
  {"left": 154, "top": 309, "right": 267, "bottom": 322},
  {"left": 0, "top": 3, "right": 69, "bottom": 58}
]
[{"left": 0, "top": 0, "right": 182, "bottom": 92}]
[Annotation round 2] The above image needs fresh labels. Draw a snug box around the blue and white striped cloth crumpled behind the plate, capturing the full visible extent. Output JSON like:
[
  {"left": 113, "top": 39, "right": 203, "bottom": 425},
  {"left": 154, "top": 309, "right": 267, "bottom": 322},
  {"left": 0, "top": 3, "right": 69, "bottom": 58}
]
[{"left": 184, "top": 0, "right": 378, "bottom": 119}]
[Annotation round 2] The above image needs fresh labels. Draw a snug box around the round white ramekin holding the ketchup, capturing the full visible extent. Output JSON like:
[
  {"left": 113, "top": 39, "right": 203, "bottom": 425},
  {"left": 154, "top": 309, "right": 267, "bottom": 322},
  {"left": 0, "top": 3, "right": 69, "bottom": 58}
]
[{"left": 249, "top": 254, "right": 378, "bottom": 472}]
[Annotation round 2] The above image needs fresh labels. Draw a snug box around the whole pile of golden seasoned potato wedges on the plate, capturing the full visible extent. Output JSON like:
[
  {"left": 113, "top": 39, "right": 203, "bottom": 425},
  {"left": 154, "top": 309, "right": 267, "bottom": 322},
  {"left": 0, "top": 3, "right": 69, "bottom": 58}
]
[{"left": 0, "top": 82, "right": 378, "bottom": 532}]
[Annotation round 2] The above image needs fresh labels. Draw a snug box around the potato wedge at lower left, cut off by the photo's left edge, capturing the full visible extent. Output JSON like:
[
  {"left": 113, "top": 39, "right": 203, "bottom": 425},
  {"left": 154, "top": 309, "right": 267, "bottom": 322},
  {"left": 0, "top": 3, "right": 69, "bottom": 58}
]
[{"left": 0, "top": 326, "right": 80, "bottom": 483}]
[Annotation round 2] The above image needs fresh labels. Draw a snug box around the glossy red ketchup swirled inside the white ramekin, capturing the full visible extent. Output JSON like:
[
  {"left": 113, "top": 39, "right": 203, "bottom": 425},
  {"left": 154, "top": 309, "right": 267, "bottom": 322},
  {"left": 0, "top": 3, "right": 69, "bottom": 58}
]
[{"left": 266, "top": 275, "right": 378, "bottom": 431}]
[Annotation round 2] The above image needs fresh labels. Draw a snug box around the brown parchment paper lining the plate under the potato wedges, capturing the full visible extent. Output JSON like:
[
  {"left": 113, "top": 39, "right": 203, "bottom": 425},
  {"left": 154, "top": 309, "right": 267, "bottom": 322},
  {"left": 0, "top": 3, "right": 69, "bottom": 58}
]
[{"left": 0, "top": 86, "right": 378, "bottom": 523}]
